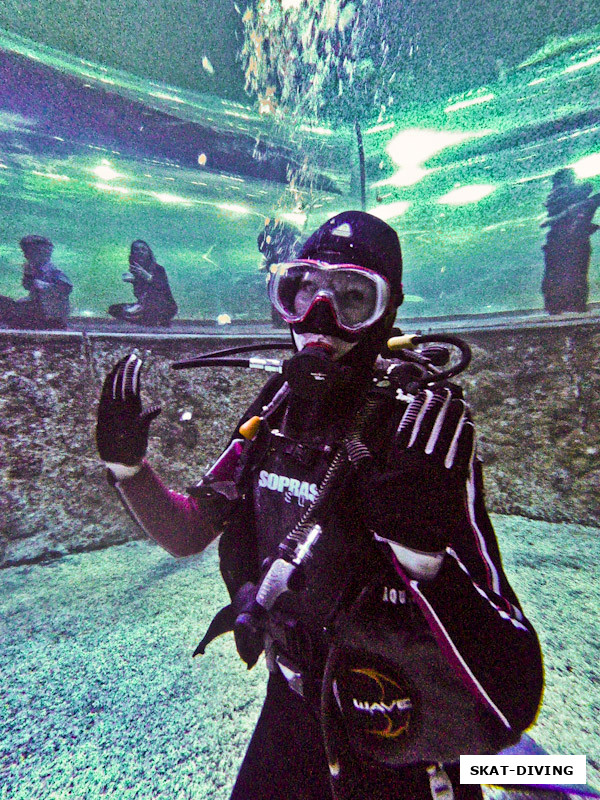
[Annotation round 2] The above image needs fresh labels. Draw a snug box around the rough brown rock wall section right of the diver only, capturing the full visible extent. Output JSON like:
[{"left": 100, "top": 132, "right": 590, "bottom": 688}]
[{"left": 460, "top": 326, "right": 600, "bottom": 525}]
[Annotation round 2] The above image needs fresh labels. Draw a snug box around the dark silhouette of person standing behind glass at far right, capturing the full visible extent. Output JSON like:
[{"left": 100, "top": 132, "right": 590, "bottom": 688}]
[{"left": 541, "top": 169, "right": 600, "bottom": 314}]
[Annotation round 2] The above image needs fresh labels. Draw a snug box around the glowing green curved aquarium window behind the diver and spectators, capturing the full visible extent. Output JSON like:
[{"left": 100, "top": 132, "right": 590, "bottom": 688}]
[{"left": 0, "top": 27, "right": 600, "bottom": 320}]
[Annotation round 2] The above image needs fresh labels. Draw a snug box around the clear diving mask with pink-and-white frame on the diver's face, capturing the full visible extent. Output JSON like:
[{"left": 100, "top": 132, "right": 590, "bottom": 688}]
[{"left": 269, "top": 259, "right": 391, "bottom": 333}]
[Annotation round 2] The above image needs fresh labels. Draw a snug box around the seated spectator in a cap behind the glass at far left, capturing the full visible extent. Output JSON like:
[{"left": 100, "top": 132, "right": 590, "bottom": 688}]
[{"left": 0, "top": 235, "right": 73, "bottom": 329}]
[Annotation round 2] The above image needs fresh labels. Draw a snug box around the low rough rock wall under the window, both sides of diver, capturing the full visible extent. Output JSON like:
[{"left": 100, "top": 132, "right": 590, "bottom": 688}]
[{"left": 0, "top": 324, "right": 600, "bottom": 566}]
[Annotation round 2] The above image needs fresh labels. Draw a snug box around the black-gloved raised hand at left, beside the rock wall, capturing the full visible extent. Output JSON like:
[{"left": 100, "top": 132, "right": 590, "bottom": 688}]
[{"left": 96, "top": 353, "right": 161, "bottom": 468}]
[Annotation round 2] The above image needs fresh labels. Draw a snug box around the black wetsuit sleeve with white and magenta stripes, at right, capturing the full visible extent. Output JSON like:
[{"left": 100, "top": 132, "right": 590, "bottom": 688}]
[{"left": 376, "top": 461, "right": 543, "bottom": 732}]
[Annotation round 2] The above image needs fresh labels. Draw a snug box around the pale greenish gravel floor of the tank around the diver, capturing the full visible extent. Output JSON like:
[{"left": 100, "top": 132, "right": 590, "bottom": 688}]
[{"left": 0, "top": 515, "right": 600, "bottom": 800}]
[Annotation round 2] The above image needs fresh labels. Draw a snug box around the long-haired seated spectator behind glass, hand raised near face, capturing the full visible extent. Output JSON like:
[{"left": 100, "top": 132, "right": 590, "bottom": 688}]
[{"left": 108, "top": 239, "right": 177, "bottom": 327}]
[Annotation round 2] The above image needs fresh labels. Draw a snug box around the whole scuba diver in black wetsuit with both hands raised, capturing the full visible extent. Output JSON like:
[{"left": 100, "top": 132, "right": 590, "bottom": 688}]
[{"left": 96, "top": 211, "right": 543, "bottom": 800}]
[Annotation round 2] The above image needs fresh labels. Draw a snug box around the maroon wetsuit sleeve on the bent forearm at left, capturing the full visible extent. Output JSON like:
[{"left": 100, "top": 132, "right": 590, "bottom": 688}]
[{"left": 111, "top": 462, "right": 225, "bottom": 556}]
